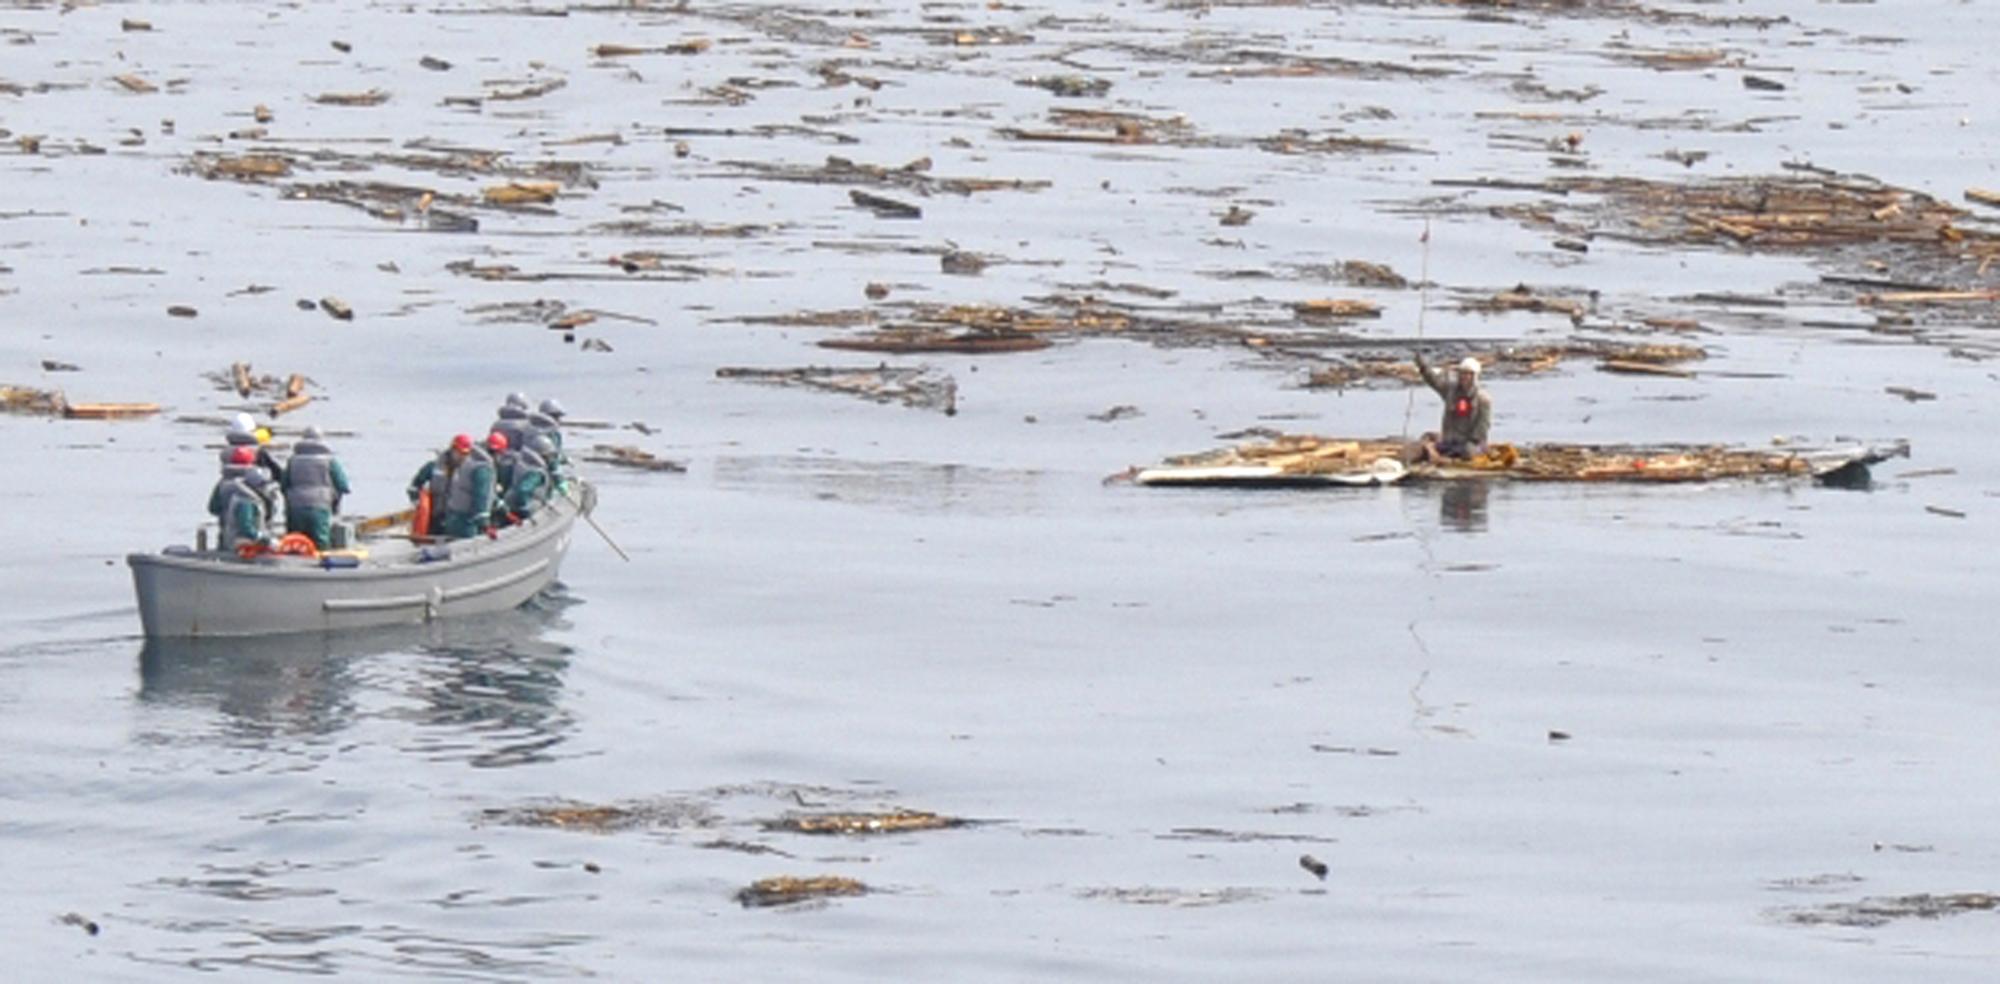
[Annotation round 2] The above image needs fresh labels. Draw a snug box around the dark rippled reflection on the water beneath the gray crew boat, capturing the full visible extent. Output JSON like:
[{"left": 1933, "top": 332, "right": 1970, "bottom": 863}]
[{"left": 138, "top": 588, "right": 574, "bottom": 766}]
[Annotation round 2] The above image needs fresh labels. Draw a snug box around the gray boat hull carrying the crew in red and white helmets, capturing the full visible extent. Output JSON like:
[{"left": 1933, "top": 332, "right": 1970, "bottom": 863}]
[{"left": 126, "top": 480, "right": 598, "bottom": 638}]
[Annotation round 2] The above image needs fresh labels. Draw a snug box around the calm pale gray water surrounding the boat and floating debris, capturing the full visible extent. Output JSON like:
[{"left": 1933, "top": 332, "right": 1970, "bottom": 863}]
[{"left": 0, "top": 0, "right": 2000, "bottom": 982}]
